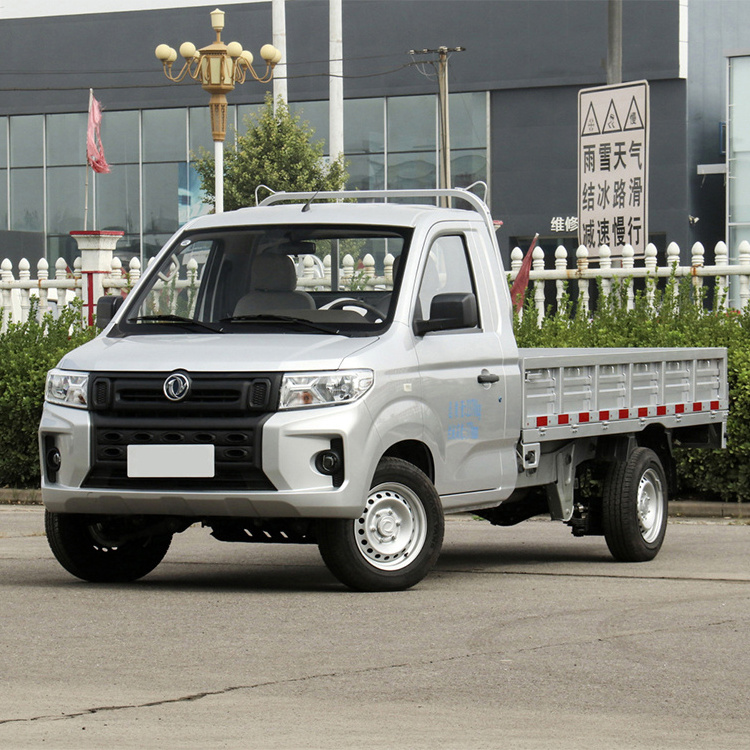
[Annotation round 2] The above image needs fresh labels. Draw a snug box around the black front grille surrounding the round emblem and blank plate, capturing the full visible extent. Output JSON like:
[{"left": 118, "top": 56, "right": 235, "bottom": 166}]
[{"left": 83, "top": 373, "right": 281, "bottom": 491}]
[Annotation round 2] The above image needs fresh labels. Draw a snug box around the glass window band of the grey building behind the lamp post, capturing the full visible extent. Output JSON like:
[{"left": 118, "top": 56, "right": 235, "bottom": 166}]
[{"left": 0, "top": 92, "right": 490, "bottom": 263}]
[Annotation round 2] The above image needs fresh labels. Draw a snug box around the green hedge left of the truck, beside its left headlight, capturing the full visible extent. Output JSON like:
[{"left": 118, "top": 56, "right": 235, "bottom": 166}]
[{"left": 0, "top": 303, "right": 94, "bottom": 488}]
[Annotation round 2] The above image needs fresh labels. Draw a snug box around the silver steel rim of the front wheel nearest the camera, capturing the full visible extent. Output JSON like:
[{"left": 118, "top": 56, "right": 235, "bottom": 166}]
[{"left": 354, "top": 482, "right": 427, "bottom": 571}]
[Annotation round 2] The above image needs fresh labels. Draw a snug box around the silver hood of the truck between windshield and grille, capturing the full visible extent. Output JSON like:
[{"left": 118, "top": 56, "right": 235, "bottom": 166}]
[{"left": 58, "top": 334, "right": 377, "bottom": 372}]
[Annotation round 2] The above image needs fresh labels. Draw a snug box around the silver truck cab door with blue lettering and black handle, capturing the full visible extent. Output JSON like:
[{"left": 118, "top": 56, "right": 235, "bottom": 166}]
[{"left": 413, "top": 231, "right": 518, "bottom": 508}]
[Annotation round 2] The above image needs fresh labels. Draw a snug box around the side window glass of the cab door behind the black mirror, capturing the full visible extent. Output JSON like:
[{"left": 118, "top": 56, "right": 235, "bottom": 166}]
[{"left": 415, "top": 235, "right": 476, "bottom": 328}]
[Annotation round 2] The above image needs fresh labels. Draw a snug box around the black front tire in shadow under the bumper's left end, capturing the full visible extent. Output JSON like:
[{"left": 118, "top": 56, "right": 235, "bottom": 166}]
[{"left": 44, "top": 511, "right": 172, "bottom": 583}]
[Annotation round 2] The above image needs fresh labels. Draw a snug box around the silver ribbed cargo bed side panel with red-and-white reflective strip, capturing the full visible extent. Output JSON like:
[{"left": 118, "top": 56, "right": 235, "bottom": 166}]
[{"left": 519, "top": 348, "right": 728, "bottom": 443}]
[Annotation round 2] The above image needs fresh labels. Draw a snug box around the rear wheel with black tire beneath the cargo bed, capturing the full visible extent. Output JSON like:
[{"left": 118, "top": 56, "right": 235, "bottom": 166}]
[{"left": 602, "top": 448, "right": 668, "bottom": 562}]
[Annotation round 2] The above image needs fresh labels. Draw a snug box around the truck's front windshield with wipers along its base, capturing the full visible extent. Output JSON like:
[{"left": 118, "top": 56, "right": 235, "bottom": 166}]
[{"left": 119, "top": 225, "right": 409, "bottom": 335}]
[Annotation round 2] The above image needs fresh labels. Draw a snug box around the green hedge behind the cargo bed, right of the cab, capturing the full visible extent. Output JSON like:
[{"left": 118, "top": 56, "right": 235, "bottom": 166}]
[{"left": 515, "top": 278, "right": 750, "bottom": 502}]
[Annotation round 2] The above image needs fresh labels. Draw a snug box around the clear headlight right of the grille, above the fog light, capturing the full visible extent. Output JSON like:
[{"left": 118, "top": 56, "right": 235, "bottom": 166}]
[{"left": 279, "top": 370, "right": 374, "bottom": 409}]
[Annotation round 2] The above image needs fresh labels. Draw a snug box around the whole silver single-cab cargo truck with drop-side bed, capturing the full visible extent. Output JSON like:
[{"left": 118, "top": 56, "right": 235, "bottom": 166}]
[{"left": 39, "top": 189, "right": 728, "bottom": 591}]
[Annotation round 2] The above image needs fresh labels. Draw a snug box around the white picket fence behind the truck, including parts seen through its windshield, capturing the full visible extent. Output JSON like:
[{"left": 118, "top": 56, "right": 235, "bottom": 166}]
[{"left": 0, "top": 241, "right": 750, "bottom": 330}]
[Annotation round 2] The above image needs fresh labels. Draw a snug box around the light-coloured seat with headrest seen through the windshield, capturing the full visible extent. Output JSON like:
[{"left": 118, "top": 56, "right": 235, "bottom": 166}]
[{"left": 234, "top": 255, "right": 315, "bottom": 315}]
